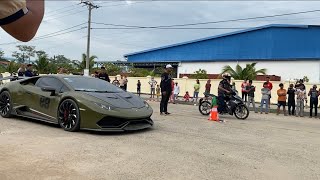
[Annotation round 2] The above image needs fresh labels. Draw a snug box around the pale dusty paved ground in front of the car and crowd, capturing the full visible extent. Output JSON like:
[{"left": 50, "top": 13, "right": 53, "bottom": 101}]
[{"left": 0, "top": 102, "right": 320, "bottom": 180}]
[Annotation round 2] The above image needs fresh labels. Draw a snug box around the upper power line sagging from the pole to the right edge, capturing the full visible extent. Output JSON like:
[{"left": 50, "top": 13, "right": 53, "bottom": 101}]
[{"left": 92, "top": 10, "right": 320, "bottom": 28}]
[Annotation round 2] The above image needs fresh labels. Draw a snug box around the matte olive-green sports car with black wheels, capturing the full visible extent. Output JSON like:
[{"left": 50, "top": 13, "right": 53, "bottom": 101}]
[{"left": 0, "top": 75, "right": 153, "bottom": 131}]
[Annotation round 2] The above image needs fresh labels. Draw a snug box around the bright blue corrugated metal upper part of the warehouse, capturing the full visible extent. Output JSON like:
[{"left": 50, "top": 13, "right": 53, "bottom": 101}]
[{"left": 127, "top": 26, "right": 320, "bottom": 62}]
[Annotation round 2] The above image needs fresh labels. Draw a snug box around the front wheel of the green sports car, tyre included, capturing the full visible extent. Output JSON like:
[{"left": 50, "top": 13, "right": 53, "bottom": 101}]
[{"left": 58, "top": 99, "right": 80, "bottom": 132}]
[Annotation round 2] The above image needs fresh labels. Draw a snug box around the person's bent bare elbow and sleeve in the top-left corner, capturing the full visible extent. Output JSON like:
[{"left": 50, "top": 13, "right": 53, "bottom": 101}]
[{"left": 0, "top": 0, "right": 44, "bottom": 42}]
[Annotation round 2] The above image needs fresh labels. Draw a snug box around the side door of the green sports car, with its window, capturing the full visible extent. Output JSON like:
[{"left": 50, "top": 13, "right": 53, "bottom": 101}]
[{"left": 30, "top": 77, "right": 65, "bottom": 121}]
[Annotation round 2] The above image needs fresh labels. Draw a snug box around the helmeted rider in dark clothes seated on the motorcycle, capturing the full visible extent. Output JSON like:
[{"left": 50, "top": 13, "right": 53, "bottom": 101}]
[{"left": 218, "top": 74, "right": 231, "bottom": 113}]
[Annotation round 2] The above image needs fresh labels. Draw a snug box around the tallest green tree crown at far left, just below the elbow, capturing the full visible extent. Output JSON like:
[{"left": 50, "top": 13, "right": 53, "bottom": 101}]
[{"left": 12, "top": 45, "right": 36, "bottom": 63}]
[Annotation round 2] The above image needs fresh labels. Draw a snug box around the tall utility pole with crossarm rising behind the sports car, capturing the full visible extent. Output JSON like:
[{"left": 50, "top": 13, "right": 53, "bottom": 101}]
[{"left": 81, "top": 0, "right": 99, "bottom": 76}]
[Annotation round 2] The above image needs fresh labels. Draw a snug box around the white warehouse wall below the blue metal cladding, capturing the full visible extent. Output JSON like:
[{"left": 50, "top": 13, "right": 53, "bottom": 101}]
[{"left": 178, "top": 61, "right": 320, "bottom": 83}]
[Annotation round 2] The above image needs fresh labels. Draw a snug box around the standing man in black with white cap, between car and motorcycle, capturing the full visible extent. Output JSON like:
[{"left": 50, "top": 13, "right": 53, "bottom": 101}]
[{"left": 160, "top": 64, "right": 173, "bottom": 115}]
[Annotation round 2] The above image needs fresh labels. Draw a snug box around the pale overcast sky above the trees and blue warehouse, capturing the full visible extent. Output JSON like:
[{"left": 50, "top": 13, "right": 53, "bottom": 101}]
[{"left": 0, "top": 1, "right": 320, "bottom": 61}]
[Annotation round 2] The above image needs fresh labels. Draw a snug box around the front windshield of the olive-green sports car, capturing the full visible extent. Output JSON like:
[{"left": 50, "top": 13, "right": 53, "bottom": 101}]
[{"left": 63, "top": 76, "right": 123, "bottom": 93}]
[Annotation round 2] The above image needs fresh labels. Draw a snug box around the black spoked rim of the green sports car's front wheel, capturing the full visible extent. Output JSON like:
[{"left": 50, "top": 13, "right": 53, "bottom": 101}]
[{"left": 59, "top": 101, "right": 79, "bottom": 130}]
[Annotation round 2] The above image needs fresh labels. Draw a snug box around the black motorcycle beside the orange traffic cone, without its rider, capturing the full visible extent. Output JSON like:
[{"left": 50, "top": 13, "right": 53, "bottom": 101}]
[{"left": 199, "top": 90, "right": 249, "bottom": 120}]
